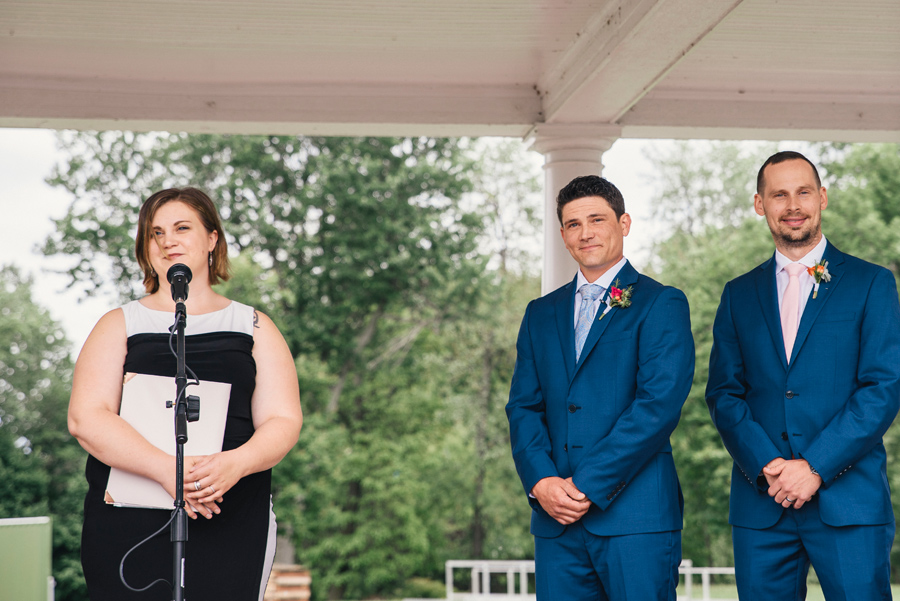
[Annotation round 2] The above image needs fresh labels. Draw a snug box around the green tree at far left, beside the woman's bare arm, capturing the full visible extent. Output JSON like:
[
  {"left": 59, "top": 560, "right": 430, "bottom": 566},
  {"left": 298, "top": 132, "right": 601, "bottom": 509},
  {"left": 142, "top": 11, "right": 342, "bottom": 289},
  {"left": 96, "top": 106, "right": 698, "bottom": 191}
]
[{"left": 0, "top": 266, "right": 87, "bottom": 601}]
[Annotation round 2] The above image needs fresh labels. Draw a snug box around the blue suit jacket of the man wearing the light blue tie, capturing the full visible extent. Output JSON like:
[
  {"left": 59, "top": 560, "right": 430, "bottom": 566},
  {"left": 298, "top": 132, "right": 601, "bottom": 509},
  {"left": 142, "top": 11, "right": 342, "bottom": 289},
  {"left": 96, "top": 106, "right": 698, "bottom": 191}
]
[{"left": 506, "top": 263, "right": 694, "bottom": 537}]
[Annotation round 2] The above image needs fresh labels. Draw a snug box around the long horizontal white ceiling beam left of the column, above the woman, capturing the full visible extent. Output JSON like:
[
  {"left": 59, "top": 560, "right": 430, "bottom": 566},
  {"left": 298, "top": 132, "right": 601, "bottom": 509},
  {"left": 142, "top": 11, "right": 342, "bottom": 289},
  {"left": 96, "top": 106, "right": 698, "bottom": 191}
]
[{"left": 0, "top": 76, "right": 540, "bottom": 136}]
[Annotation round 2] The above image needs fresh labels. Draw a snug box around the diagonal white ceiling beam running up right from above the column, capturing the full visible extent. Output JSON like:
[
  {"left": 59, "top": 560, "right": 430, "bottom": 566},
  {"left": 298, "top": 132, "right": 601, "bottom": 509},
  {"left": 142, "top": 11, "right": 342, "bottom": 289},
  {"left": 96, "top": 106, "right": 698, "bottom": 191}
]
[{"left": 538, "top": 0, "right": 742, "bottom": 123}]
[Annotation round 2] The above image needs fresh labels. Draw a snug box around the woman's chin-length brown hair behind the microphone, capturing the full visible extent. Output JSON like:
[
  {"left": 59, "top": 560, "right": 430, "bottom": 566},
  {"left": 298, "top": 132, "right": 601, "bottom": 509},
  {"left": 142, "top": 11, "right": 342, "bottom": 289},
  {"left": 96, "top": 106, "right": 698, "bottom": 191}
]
[{"left": 134, "top": 188, "right": 231, "bottom": 294}]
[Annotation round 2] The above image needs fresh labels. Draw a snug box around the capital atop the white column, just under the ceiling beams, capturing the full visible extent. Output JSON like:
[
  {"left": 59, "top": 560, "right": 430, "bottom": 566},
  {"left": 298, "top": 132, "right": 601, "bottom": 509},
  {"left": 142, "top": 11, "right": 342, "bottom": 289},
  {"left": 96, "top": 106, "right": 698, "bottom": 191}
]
[{"left": 525, "top": 123, "right": 622, "bottom": 162}]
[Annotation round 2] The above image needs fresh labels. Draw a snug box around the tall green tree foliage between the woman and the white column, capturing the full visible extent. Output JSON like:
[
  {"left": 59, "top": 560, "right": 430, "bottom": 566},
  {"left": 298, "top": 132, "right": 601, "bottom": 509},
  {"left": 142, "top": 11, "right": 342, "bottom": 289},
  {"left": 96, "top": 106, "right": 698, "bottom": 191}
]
[{"left": 45, "top": 132, "right": 537, "bottom": 598}]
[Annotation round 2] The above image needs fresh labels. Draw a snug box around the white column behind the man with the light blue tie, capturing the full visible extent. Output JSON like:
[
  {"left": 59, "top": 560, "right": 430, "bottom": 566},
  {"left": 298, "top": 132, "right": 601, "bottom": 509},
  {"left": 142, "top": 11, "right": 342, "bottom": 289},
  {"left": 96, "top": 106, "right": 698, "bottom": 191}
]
[{"left": 529, "top": 123, "right": 622, "bottom": 294}]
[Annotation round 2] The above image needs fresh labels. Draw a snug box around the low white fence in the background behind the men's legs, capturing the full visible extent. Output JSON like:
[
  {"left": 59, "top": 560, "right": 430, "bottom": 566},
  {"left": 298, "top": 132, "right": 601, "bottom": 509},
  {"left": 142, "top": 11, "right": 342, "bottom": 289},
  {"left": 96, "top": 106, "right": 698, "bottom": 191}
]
[{"left": 444, "top": 559, "right": 734, "bottom": 601}]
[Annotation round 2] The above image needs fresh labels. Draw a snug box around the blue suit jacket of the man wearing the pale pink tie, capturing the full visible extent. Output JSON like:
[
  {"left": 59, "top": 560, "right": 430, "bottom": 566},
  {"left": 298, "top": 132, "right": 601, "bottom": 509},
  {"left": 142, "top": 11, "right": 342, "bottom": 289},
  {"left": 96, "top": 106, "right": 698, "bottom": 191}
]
[{"left": 706, "top": 244, "right": 900, "bottom": 529}]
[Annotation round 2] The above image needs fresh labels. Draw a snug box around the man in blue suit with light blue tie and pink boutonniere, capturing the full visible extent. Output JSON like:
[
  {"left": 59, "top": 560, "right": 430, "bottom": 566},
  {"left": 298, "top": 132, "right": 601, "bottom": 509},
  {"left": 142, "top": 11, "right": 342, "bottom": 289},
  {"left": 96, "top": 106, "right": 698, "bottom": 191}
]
[{"left": 506, "top": 176, "right": 694, "bottom": 601}]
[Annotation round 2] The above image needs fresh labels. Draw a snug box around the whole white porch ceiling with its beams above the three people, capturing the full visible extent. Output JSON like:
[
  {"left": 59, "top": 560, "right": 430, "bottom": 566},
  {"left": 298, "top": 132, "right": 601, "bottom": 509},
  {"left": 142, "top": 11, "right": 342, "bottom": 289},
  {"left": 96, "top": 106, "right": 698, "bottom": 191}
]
[{"left": 0, "top": 0, "right": 900, "bottom": 141}]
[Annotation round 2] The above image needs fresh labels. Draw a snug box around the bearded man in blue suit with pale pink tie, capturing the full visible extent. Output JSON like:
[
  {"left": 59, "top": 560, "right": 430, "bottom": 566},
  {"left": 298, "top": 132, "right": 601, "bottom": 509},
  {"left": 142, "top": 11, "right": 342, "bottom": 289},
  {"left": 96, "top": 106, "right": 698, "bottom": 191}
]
[{"left": 706, "top": 152, "right": 900, "bottom": 601}]
